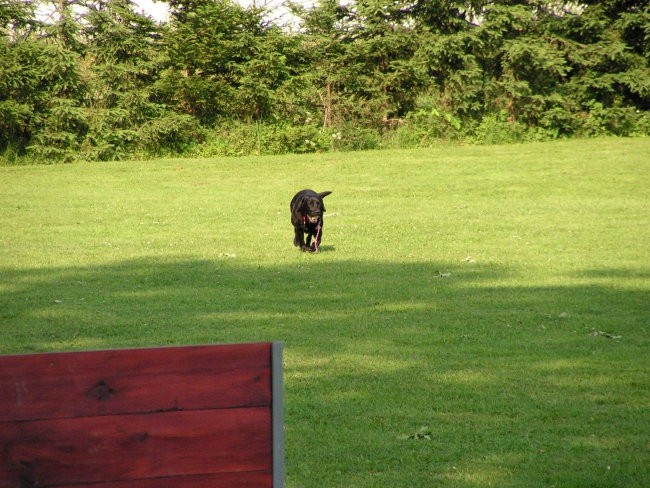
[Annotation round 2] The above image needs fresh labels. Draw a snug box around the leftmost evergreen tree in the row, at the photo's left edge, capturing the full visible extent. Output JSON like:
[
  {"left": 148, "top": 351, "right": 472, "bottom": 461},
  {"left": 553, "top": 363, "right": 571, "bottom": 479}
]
[{"left": 0, "top": 0, "right": 87, "bottom": 160}]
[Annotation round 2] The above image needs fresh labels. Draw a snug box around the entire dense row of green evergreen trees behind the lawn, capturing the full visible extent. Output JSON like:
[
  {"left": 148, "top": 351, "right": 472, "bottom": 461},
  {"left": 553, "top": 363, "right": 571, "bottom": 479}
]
[{"left": 0, "top": 0, "right": 650, "bottom": 162}]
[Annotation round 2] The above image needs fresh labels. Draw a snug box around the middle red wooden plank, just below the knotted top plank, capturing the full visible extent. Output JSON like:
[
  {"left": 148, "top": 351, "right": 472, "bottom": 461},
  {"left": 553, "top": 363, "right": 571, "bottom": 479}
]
[{"left": 0, "top": 407, "right": 272, "bottom": 488}]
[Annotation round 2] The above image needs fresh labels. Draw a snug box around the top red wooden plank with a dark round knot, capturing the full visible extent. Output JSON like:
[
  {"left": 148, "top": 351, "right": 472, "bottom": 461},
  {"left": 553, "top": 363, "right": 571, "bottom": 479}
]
[{"left": 0, "top": 344, "right": 271, "bottom": 421}]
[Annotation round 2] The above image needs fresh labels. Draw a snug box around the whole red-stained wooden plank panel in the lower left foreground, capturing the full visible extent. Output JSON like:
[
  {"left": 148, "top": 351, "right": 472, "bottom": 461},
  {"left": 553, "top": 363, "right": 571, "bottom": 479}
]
[{"left": 0, "top": 344, "right": 273, "bottom": 488}]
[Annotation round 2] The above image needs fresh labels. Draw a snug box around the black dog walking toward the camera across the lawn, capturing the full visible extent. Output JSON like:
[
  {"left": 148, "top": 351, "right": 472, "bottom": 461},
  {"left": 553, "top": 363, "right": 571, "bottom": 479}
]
[{"left": 289, "top": 190, "right": 332, "bottom": 252}]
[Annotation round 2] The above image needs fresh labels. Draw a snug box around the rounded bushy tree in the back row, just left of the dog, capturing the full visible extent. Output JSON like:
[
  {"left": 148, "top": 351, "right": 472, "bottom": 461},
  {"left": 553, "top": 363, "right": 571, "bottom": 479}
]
[{"left": 157, "top": 0, "right": 299, "bottom": 125}]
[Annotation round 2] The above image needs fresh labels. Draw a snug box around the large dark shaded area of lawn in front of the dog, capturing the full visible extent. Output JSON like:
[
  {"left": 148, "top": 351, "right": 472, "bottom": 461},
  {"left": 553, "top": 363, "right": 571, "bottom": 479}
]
[{"left": 0, "top": 257, "right": 650, "bottom": 487}]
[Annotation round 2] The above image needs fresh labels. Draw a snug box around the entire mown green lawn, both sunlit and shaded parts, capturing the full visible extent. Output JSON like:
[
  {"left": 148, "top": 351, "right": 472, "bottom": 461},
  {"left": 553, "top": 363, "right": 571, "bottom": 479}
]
[{"left": 0, "top": 139, "right": 650, "bottom": 488}]
